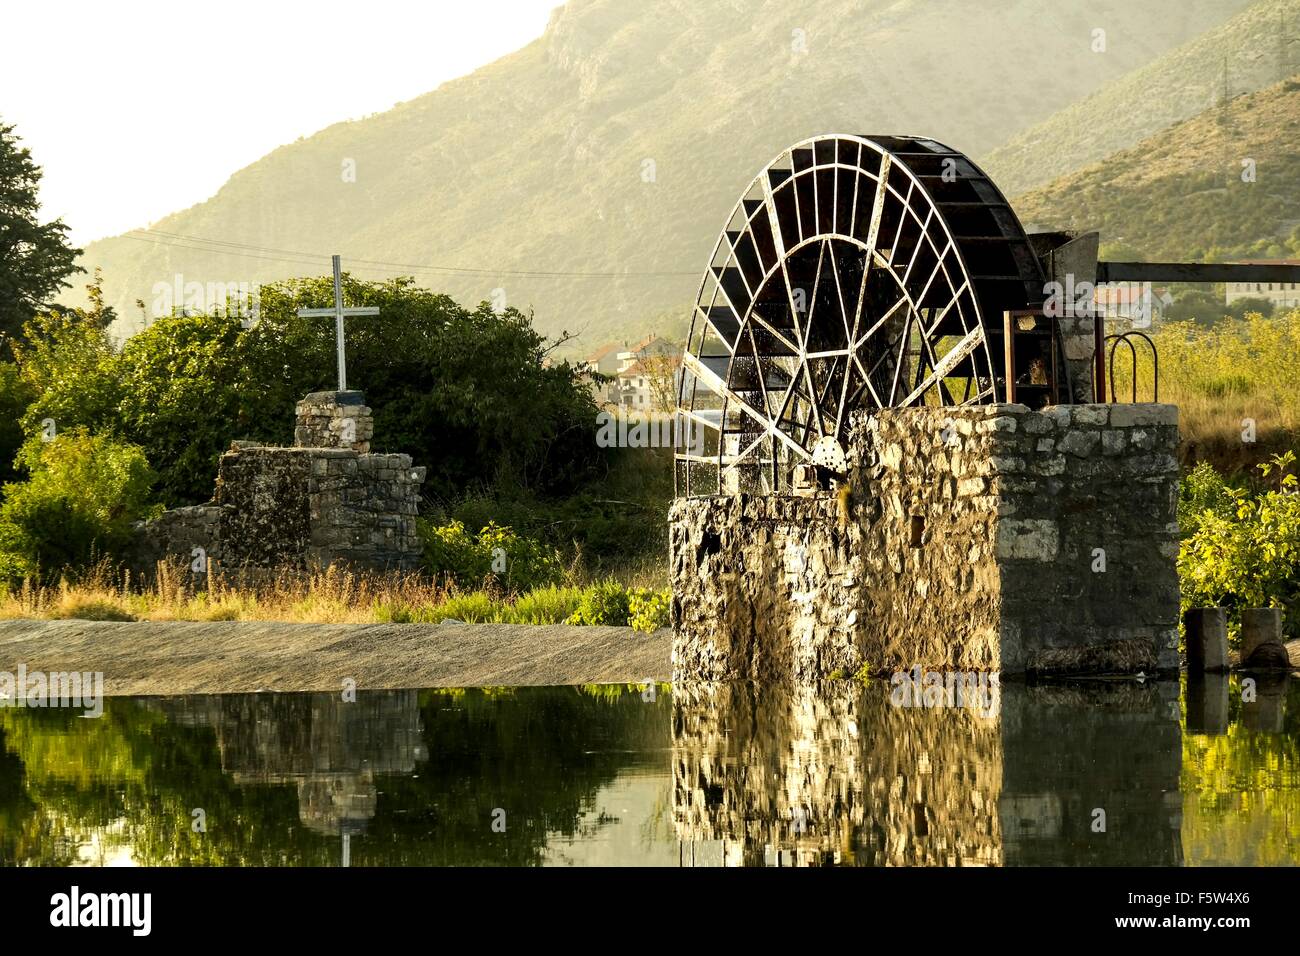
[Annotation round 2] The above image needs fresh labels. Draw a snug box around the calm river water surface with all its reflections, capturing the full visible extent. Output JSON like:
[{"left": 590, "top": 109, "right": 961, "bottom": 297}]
[{"left": 0, "top": 676, "right": 1300, "bottom": 866}]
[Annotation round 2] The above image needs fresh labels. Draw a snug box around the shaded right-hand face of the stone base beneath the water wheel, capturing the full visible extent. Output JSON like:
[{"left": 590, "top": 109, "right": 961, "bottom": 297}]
[{"left": 997, "top": 405, "right": 1178, "bottom": 674}]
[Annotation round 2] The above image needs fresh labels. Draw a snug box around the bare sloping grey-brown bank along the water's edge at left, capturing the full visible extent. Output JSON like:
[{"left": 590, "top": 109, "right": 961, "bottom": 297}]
[{"left": 0, "top": 619, "right": 672, "bottom": 696}]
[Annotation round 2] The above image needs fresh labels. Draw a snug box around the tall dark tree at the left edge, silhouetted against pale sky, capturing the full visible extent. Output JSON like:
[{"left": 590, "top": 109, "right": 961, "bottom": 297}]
[{"left": 0, "top": 124, "right": 82, "bottom": 356}]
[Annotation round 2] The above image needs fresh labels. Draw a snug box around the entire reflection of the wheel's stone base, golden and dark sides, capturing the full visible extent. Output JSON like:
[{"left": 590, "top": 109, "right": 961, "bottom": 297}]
[{"left": 673, "top": 682, "right": 1180, "bottom": 866}]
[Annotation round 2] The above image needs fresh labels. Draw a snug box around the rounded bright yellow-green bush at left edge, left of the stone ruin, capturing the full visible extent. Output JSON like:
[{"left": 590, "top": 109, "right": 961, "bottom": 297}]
[{"left": 0, "top": 431, "right": 159, "bottom": 580}]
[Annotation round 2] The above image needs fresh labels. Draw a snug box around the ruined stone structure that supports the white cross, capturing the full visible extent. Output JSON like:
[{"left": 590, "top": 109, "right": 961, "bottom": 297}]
[{"left": 131, "top": 392, "right": 425, "bottom": 574}]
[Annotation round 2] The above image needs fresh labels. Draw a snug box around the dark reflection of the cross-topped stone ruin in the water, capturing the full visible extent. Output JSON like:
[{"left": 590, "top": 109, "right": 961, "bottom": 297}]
[{"left": 159, "top": 691, "right": 426, "bottom": 864}]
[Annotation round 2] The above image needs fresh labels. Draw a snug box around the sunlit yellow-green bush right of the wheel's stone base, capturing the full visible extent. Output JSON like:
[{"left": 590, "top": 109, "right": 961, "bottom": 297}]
[{"left": 1178, "top": 453, "right": 1300, "bottom": 639}]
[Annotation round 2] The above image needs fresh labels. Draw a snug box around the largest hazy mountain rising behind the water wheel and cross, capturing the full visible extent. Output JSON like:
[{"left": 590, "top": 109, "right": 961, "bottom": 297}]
[{"left": 83, "top": 0, "right": 1247, "bottom": 350}]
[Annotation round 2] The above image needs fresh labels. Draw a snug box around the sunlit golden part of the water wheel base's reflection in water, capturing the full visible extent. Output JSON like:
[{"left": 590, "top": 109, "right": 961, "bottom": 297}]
[{"left": 673, "top": 683, "right": 1001, "bottom": 866}]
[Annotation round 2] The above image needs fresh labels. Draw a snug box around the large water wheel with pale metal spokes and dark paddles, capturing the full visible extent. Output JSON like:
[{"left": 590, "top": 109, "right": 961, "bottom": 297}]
[{"left": 677, "top": 135, "right": 1043, "bottom": 494}]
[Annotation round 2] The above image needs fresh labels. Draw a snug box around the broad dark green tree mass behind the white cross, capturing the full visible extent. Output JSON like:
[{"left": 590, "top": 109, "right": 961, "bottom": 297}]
[{"left": 0, "top": 269, "right": 602, "bottom": 527}]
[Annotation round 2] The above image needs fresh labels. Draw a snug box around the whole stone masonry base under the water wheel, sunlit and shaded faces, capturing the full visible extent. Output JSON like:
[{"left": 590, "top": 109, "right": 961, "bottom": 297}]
[{"left": 670, "top": 405, "right": 1178, "bottom": 682}]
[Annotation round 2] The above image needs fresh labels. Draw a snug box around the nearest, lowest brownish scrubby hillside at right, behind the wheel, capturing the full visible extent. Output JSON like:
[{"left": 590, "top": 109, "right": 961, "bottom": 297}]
[{"left": 1011, "top": 74, "right": 1300, "bottom": 260}]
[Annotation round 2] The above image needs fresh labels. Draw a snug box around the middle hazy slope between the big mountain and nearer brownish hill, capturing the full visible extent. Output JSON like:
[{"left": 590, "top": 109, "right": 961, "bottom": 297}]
[{"left": 982, "top": 0, "right": 1300, "bottom": 195}]
